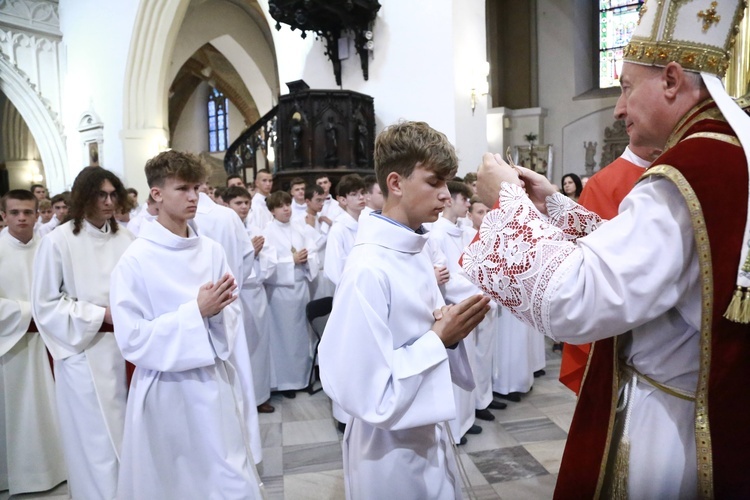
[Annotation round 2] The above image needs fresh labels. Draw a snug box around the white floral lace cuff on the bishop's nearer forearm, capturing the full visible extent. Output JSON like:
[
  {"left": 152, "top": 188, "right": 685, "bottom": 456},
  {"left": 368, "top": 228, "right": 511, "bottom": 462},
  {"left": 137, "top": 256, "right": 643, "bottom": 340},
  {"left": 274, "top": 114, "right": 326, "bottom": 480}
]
[{"left": 462, "top": 183, "right": 581, "bottom": 335}]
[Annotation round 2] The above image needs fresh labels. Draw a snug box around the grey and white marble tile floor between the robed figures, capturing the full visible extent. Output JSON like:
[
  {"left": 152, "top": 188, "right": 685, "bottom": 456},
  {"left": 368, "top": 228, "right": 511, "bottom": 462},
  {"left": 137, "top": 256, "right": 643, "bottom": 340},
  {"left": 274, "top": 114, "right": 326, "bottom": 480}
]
[{"left": 0, "top": 344, "right": 575, "bottom": 500}]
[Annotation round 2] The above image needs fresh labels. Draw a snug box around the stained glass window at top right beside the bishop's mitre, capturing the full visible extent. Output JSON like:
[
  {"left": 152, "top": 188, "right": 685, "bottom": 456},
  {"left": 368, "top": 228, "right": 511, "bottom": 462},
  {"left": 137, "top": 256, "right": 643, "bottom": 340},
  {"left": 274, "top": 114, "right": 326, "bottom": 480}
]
[{"left": 599, "top": 0, "right": 643, "bottom": 89}]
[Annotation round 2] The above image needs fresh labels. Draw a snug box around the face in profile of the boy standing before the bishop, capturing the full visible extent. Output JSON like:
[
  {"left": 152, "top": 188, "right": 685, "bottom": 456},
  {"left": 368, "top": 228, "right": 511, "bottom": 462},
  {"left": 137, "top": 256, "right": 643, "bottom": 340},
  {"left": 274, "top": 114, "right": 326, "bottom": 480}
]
[{"left": 400, "top": 166, "right": 451, "bottom": 229}]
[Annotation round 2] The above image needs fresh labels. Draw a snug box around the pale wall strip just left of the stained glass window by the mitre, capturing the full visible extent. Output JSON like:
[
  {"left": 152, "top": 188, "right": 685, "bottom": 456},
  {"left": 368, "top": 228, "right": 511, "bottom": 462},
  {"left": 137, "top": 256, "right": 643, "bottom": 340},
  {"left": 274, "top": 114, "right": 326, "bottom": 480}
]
[{"left": 537, "top": 0, "right": 617, "bottom": 183}]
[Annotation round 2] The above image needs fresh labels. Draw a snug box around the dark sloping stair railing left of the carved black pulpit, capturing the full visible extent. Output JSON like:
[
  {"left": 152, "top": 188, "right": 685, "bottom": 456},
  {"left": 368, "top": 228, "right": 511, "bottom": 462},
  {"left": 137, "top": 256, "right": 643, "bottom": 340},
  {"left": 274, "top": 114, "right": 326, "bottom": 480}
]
[{"left": 224, "top": 106, "right": 279, "bottom": 183}]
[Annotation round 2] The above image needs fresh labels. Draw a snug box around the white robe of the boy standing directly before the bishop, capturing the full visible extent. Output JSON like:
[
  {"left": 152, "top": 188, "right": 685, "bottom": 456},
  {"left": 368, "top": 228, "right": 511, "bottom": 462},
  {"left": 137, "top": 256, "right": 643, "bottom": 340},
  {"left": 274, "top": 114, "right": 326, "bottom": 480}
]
[{"left": 319, "top": 215, "right": 473, "bottom": 499}]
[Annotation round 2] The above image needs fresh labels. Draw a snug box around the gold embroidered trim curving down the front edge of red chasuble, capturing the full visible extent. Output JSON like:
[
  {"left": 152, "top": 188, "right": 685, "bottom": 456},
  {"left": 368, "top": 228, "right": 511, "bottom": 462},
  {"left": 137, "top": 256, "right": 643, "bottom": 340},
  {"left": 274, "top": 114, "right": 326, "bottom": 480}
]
[{"left": 641, "top": 165, "right": 714, "bottom": 499}]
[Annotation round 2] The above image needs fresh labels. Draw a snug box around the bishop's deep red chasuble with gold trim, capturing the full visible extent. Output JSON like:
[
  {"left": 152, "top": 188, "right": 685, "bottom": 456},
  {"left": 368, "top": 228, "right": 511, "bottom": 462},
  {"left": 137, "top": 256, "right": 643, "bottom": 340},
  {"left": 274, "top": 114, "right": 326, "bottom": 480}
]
[{"left": 555, "top": 100, "right": 750, "bottom": 499}]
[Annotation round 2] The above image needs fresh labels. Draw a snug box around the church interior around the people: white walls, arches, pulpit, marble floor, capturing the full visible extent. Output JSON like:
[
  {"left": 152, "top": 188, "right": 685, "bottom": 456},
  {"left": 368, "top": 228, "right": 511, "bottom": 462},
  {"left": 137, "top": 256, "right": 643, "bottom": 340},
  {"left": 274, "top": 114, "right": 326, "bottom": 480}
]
[{"left": 0, "top": 0, "right": 750, "bottom": 500}]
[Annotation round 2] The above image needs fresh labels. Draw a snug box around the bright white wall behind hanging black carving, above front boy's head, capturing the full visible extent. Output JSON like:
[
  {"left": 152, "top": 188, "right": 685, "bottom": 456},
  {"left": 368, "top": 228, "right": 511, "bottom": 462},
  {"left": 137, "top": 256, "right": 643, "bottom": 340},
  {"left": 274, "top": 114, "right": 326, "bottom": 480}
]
[{"left": 261, "top": 0, "right": 487, "bottom": 172}]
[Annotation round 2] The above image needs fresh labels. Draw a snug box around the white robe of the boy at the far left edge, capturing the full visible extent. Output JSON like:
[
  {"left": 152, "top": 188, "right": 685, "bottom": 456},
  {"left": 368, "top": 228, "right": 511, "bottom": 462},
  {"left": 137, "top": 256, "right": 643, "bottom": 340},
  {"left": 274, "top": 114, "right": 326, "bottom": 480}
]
[{"left": 0, "top": 232, "right": 65, "bottom": 495}]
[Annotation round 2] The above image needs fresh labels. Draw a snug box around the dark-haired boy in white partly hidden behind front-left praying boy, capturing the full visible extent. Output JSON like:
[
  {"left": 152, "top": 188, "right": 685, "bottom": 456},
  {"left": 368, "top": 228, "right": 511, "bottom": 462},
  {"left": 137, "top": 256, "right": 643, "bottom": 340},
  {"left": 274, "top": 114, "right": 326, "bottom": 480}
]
[{"left": 226, "top": 186, "right": 276, "bottom": 413}]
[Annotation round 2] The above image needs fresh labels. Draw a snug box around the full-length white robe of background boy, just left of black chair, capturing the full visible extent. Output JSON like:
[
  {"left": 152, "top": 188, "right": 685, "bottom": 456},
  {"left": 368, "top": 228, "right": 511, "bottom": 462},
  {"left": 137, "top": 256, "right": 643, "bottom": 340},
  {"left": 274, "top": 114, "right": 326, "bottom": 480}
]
[{"left": 264, "top": 220, "right": 320, "bottom": 391}]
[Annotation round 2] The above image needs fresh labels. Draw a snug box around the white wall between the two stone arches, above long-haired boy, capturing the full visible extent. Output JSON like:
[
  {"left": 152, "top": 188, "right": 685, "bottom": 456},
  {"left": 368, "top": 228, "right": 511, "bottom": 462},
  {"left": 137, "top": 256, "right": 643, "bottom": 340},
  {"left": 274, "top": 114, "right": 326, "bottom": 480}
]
[{"left": 60, "top": 0, "right": 141, "bottom": 187}]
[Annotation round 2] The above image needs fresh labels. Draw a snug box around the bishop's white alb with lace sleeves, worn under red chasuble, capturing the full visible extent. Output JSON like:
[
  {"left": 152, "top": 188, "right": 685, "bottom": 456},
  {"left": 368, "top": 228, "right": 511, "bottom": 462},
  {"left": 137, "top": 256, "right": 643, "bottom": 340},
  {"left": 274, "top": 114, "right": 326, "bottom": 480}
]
[{"left": 464, "top": 181, "right": 704, "bottom": 498}]
